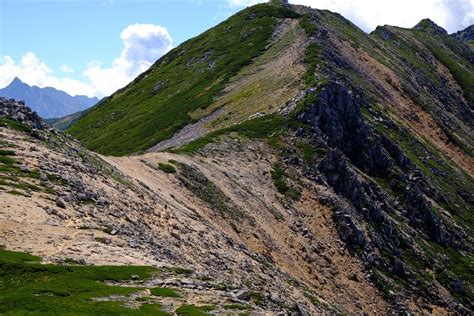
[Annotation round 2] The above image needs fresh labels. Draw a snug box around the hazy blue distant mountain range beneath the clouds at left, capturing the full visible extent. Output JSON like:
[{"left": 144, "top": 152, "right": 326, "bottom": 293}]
[{"left": 0, "top": 77, "right": 99, "bottom": 119}]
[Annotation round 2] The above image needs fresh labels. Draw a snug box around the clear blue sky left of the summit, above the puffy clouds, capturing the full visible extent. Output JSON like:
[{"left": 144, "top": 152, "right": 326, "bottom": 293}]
[{"left": 0, "top": 0, "right": 235, "bottom": 79}]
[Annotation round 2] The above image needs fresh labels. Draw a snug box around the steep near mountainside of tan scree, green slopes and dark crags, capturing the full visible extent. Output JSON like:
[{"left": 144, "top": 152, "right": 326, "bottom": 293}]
[{"left": 0, "top": 1, "right": 474, "bottom": 315}]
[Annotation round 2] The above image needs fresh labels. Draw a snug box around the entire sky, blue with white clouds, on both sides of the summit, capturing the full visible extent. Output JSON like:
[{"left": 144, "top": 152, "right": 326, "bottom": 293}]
[{"left": 0, "top": 0, "right": 474, "bottom": 97}]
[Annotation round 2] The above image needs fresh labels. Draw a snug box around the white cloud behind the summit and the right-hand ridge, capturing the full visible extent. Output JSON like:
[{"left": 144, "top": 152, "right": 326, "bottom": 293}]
[{"left": 228, "top": 0, "right": 474, "bottom": 33}]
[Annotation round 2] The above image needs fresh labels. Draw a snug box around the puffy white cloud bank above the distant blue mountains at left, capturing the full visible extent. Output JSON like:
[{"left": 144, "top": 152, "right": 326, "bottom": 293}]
[{"left": 0, "top": 24, "right": 173, "bottom": 97}]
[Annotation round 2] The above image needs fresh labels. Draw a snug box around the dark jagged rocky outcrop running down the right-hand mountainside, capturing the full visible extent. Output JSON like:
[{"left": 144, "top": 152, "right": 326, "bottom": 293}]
[{"left": 297, "top": 82, "right": 470, "bottom": 312}]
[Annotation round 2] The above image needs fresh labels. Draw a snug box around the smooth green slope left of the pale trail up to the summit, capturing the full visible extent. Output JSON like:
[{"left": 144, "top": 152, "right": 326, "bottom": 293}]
[{"left": 69, "top": 4, "right": 298, "bottom": 155}]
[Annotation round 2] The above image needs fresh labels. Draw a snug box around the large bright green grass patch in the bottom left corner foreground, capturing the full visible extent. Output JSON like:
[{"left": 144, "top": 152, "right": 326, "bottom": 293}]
[{"left": 0, "top": 250, "right": 165, "bottom": 315}]
